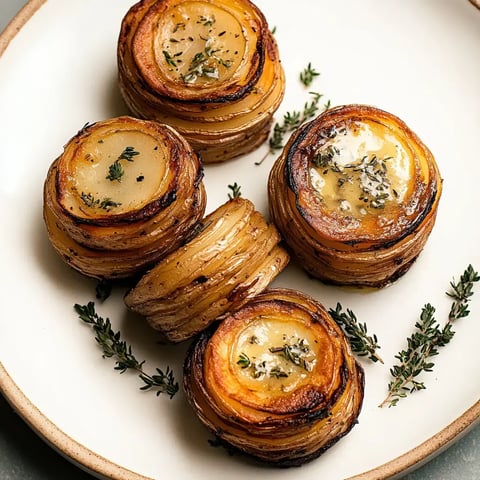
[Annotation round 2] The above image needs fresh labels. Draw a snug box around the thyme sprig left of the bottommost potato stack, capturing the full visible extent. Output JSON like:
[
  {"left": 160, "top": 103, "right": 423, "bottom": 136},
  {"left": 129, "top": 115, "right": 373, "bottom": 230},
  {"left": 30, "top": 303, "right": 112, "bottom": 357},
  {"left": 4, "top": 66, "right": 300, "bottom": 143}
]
[{"left": 74, "top": 302, "right": 179, "bottom": 398}]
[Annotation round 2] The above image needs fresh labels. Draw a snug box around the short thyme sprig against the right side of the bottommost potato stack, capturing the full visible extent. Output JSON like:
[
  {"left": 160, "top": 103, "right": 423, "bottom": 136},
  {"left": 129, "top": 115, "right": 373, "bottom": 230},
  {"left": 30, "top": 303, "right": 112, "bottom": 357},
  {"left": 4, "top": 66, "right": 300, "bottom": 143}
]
[{"left": 328, "top": 303, "right": 383, "bottom": 363}]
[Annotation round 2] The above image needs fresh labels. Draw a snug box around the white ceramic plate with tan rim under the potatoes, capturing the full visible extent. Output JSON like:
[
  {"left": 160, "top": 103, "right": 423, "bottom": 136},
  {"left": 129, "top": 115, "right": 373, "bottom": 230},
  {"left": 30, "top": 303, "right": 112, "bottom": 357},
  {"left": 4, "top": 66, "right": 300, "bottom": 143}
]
[{"left": 0, "top": 0, "right": 480, "bottom": 480}]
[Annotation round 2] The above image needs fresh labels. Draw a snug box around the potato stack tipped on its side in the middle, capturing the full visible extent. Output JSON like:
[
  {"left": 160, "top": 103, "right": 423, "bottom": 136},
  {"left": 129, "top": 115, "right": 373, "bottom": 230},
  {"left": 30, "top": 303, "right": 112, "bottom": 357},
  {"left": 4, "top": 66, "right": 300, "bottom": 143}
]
[{"left": 125, "top": 197, "right": 289, "bottom": 343}]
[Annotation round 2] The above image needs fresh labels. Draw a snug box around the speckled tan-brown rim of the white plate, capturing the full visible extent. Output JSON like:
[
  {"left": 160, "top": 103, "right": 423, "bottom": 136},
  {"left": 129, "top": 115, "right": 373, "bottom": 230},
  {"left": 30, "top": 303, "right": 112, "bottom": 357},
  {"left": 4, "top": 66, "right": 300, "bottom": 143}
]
[{"left": 0, "top": 0, "right": 480, "bottom": 480}]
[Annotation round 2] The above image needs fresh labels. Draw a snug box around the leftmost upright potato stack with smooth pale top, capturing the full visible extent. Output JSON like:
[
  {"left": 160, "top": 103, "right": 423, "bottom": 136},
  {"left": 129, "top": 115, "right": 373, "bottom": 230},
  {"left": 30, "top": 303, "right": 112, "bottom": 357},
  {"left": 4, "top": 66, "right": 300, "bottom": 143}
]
[{"left": 43, "top": 116, "right": 206, "bottom": 279}]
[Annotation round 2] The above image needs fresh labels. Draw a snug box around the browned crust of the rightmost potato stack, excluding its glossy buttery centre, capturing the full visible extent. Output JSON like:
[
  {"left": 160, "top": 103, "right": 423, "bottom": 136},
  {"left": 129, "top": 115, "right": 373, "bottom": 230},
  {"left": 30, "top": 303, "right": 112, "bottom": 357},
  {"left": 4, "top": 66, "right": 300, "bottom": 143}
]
[{"left": 268, "top": 105, "right": 442, "bottom": 287}]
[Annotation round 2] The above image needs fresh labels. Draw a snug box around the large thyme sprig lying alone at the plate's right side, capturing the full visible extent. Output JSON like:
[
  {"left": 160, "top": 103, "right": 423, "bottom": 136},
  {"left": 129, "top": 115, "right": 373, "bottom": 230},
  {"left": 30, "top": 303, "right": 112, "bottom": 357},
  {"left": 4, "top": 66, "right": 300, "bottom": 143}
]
[{"left": 380, "top": 265, "right": 480, "bottom": 407}]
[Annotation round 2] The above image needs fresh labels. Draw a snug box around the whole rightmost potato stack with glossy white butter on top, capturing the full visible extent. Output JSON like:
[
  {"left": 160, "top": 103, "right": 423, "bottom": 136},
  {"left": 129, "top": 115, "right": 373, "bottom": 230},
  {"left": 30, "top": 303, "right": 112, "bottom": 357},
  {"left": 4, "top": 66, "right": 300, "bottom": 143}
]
[{"left": 268, "top": 105, "right": 442, "bottom": 287}]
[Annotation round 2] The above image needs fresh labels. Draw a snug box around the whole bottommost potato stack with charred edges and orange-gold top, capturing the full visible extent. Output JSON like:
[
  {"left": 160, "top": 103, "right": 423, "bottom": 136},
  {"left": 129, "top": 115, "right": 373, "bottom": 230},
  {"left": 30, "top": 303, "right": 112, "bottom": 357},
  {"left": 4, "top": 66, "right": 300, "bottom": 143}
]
[{"left": 184, "top": 289, "right": 364, "bottom": 466}]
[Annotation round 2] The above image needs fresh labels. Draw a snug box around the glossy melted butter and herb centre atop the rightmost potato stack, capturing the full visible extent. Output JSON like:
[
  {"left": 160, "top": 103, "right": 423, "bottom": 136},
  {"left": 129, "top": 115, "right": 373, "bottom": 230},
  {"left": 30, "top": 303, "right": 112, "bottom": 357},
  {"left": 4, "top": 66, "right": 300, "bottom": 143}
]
[{"left": 309, "top": 120, "right": 415, "bottom": 218}]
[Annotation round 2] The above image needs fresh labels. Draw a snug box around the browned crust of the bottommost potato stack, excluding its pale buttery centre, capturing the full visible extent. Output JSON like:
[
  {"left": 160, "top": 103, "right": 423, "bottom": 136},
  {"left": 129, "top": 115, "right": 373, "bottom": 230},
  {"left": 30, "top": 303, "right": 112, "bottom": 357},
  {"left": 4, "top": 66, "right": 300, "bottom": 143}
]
[{"left": 184, "top": 289, "right": 364, "bottom": 467}]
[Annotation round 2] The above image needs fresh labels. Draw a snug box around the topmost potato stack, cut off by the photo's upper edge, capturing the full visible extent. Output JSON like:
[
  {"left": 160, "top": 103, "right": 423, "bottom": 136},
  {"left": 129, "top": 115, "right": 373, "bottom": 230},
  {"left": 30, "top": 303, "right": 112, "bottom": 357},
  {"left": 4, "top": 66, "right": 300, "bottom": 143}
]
[{"left": 118, "top": 0, "right": 285, "bottom": 163}]
